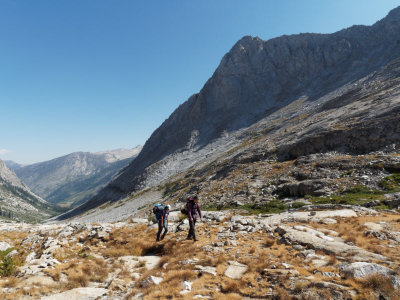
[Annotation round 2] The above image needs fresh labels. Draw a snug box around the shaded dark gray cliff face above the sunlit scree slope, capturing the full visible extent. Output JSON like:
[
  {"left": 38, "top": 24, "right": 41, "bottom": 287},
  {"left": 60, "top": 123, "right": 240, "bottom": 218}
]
[{"left": 58, "top": 8, "right": 400, "bottom": 215}]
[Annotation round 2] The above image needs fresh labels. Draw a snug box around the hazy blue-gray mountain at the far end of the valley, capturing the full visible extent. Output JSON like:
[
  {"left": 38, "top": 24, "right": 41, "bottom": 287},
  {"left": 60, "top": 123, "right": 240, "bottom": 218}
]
[{"left": 13, "top": 146, "right": 142, "bottom": 207}]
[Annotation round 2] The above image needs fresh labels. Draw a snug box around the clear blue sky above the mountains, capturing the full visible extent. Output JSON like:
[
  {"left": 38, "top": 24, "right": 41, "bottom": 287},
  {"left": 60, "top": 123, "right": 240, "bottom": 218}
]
[{"left": 0, "top": 0, "right": 400, "bottom": 164}]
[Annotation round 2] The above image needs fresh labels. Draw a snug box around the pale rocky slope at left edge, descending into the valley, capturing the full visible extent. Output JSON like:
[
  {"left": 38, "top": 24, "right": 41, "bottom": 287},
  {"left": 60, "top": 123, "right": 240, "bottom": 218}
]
[{"left": 0, "top": 160, "right": 55, "bottom": 222}]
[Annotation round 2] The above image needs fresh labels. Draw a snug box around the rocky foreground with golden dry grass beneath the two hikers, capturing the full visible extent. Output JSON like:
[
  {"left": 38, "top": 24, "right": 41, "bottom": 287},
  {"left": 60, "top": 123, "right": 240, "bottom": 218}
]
[{"left": 0, "top": 205, "right": 400, "bottom": 300}]
